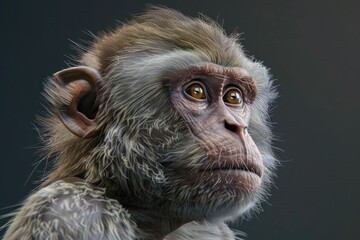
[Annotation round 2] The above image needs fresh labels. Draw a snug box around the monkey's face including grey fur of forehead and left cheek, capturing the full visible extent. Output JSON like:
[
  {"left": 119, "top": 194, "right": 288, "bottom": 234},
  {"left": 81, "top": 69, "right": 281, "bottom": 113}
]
[{"left": 83, "top": 52, "right": 265, "bottom": 219}]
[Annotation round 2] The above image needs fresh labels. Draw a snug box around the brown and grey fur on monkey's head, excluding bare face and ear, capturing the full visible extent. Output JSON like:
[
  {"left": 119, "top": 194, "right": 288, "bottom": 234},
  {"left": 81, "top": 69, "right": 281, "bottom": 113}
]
[{"left": 43, "top": 3, "right": 276, "bottom": 225}]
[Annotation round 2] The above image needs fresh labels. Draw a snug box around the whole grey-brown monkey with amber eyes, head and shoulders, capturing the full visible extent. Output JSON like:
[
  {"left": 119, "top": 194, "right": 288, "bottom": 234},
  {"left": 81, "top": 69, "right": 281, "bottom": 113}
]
[{"left": 4, "top": 7, "right": 277, "bottom": 240}]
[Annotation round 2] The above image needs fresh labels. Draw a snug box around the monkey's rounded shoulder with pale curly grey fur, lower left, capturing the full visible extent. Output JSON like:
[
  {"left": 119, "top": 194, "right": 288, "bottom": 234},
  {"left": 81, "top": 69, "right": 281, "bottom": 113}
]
[{"left": 4, "top": 180, "right": 137, "bottom": 239}]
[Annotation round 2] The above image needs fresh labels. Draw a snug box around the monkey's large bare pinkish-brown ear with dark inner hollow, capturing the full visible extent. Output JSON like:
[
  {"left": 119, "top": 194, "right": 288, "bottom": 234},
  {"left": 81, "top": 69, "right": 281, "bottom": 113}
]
[{"left": 54, "top": 66, "right": 103, "bottom": 138}]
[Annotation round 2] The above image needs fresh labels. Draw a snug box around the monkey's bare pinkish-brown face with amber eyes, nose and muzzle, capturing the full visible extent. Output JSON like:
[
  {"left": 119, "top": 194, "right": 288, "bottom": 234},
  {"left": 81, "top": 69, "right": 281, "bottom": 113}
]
[{"left": 155, "top": 63, "right": 263, "bottom": 219}]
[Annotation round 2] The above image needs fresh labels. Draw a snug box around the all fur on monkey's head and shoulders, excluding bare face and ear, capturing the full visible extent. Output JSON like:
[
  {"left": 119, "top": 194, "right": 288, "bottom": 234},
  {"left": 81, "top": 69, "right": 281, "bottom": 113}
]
[{"left": 5, "top": 7, "right": 277, "bottom": 239}]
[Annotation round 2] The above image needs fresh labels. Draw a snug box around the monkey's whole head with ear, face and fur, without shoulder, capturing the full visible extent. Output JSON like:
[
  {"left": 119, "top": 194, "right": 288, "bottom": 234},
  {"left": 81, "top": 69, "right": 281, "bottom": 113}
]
[{"left": 44, "top": 8, "right": 276, "bottom": 219}]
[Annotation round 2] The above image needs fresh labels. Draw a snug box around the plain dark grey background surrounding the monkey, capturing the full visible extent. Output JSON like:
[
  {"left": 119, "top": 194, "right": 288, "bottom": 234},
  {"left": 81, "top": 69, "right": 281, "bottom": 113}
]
[{"left": 0, "top": 0, "right": 360, "bottom": 239}]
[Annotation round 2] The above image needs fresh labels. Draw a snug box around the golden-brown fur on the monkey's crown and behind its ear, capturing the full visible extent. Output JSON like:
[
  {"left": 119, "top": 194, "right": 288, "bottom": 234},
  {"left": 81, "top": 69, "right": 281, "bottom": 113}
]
[{"left": 43, "top": 7, "right": 248, "bottom": 189}]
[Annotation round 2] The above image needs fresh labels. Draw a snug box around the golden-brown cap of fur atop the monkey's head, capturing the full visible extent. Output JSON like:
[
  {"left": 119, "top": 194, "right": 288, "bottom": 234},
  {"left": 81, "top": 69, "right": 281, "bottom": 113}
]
[{"left": 83, "top": 8, "right": 244, "bottom": 72}]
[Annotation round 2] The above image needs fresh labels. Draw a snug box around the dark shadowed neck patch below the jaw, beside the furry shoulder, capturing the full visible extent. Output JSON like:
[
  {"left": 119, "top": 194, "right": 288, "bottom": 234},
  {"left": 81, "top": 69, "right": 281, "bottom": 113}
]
[{"left": 124, "top": 206, "right": 189, "bottom": 239}]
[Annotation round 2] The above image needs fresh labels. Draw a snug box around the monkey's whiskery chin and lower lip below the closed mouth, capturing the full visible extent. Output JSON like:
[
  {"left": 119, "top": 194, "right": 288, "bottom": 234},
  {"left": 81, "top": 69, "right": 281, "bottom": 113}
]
[{"left": 169, "top": 169, "right": 262, "bottom": 220}]
